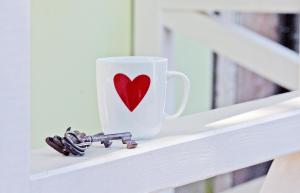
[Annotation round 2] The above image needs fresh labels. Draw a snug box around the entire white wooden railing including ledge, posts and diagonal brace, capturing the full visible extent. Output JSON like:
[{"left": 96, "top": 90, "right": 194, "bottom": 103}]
[{"left": 0, "top": 0, "right": 300, "bottom": 193}]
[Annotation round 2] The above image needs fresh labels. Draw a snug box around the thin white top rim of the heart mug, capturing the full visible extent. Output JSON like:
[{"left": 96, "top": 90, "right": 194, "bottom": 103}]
[{"left": 96, "top": 56, "right": 168, "bottom": 63}]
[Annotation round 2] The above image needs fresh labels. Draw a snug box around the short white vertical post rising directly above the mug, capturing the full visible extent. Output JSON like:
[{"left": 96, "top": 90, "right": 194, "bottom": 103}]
[{"left": 133, "top": 0, "right": 162, "bottom": 56}]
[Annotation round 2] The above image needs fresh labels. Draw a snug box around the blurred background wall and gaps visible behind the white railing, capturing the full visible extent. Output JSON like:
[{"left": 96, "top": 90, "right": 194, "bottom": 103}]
[{"left": 31, "top": 0, "right": 299, "bottom": 193}]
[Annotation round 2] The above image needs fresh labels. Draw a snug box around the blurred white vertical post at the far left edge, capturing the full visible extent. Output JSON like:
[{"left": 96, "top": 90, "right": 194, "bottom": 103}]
[{"left": 0, "top": 0, "right": 30, "bottom": 193}]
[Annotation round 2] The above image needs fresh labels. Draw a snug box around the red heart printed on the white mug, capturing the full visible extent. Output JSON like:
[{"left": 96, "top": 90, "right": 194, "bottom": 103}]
[{"left": 114, "top": 73, "right": 150, "bottom": 112}]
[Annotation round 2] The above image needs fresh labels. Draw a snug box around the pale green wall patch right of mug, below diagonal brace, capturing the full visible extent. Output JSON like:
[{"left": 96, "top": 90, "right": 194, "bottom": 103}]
[{"left": 174, "top": 33, "right": 212, "bottom": 114}]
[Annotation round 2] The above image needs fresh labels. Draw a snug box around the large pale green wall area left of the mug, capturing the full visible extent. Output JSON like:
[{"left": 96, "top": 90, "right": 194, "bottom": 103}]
[{"left": 31, "top": 0, "right": 131, "bottom": 148}]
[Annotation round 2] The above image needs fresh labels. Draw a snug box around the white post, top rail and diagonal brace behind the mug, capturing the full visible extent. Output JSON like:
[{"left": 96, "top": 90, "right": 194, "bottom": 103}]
[{"left": 135, "top": 0, "right": 300, "bottom": 192}]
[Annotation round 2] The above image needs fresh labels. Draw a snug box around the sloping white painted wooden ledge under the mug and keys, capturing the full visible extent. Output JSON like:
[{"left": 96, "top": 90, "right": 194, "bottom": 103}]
[{"left": 30, "top": 92, "right": 300, "bottom": 193}]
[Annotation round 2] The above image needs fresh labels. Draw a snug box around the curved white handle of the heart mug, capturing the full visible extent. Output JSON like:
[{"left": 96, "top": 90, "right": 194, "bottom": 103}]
[{"left": 165, "top": 71, "right": 190, "bottom": 120}]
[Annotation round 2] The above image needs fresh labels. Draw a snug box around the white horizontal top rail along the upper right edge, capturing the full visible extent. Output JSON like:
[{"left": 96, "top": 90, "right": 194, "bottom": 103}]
[{"left": 162, "top": 0, "right": 300, "bottom": 13}]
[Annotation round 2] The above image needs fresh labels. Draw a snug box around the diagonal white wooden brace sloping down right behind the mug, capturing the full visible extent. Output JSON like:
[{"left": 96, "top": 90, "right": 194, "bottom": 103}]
[{"left": 163, "top": 11, "right": 300, "bottom": 90}]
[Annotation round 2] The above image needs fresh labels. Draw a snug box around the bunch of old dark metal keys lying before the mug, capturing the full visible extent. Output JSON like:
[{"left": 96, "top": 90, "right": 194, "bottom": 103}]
[{"left": 46, "top": 127, "right": 138, "bottom": 156}]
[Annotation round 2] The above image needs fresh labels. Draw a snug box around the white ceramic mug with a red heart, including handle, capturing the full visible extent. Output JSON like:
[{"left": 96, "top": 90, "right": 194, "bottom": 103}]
[{"left": 96, "top": 56, "right": 190, "bottom": 139}]
